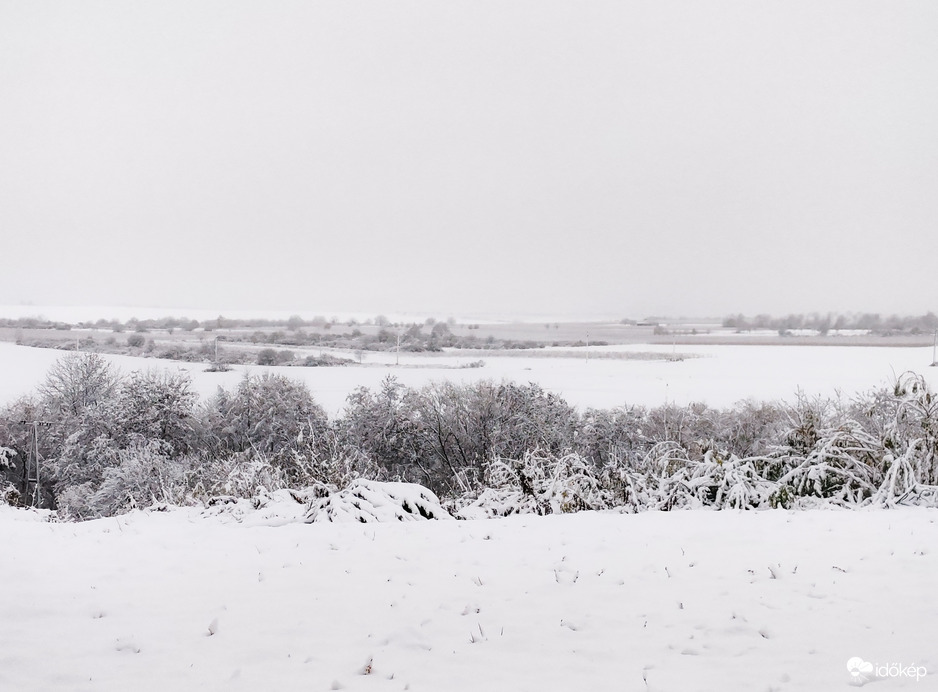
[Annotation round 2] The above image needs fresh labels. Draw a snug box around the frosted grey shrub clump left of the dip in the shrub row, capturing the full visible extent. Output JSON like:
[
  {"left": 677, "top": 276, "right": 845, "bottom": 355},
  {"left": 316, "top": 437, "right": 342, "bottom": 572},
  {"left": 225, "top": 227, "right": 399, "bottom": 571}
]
[{"left": 0, "top": 353, "right": 370, "bottom": 518}]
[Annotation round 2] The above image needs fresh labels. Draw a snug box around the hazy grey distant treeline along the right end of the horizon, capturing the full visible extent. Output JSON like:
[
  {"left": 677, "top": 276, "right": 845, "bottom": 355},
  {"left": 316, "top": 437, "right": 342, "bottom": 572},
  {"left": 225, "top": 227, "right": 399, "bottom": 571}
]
[{"left": 723, "top": 312, "right": 938, "bottom": 334}]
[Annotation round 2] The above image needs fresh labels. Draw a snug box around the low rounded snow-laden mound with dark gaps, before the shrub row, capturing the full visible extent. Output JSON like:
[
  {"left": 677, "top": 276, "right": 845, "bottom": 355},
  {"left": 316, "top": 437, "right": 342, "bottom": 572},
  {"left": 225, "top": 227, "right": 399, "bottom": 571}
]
[{"left": 306, "top": 479, "right": 453, "bottom": 524}]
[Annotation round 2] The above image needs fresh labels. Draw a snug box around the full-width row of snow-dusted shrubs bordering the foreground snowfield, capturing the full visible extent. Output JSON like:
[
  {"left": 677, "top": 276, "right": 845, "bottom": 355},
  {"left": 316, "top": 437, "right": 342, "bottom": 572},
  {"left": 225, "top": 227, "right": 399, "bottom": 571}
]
[{"left": 0, "top": 354, "right": 938, "bottom": 519}]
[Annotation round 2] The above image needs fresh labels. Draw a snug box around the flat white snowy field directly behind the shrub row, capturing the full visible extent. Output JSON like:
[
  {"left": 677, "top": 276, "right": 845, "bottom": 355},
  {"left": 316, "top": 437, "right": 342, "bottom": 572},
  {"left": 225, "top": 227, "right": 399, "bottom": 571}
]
[{"left": 0, "top": 343, "right": 938, "bottom": 414}]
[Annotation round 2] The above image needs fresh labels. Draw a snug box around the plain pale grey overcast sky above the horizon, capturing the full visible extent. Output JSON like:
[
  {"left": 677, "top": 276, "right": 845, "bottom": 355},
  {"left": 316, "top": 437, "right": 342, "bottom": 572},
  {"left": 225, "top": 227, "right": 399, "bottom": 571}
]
[{"left": 0, "top": 0, "right": 938, "bottom": 316}]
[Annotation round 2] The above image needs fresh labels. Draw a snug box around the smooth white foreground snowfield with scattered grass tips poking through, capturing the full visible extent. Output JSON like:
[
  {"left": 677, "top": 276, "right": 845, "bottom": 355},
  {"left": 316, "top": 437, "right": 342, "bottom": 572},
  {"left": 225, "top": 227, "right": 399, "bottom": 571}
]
[{"left": 0, "top": 503, "right": 938, "bottom": 692}]
